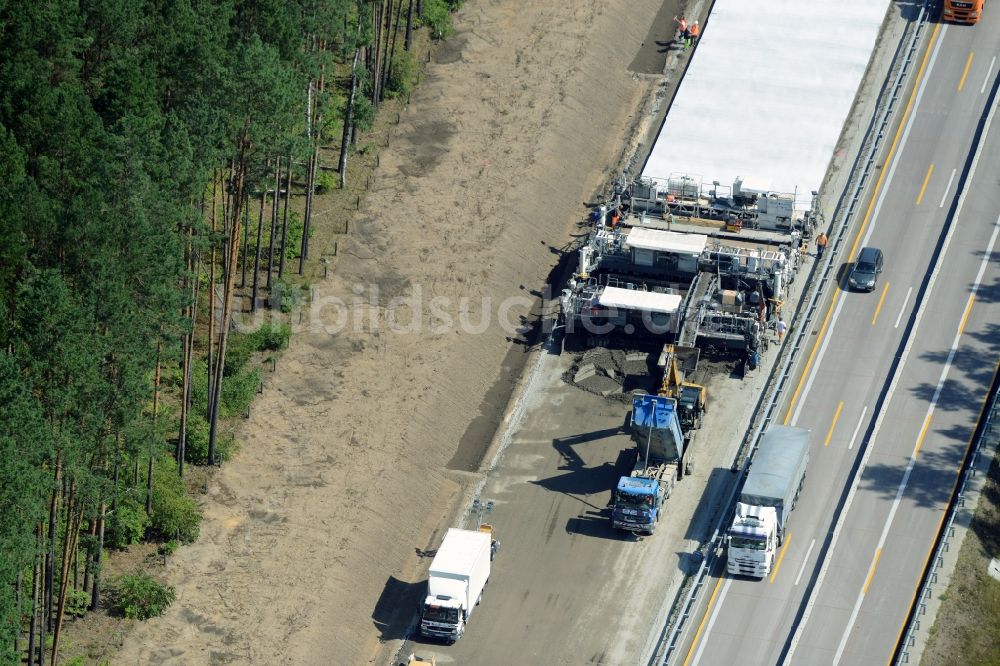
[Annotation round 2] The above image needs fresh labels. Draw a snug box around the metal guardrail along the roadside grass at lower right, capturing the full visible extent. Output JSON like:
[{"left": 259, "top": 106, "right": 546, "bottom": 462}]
[{"left": 893, "top": 368, "right": 1000, "bottom": 664}]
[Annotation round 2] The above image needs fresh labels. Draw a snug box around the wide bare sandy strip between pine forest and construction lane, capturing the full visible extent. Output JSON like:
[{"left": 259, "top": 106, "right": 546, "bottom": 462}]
[{"left": 114, "top": 0, "right": 676, "bottom": 664}]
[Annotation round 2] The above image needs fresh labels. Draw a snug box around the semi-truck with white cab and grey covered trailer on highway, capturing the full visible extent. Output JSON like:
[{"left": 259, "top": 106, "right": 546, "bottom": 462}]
[{"left": 726, "top": 426, "right": 809, "bottom": 578}]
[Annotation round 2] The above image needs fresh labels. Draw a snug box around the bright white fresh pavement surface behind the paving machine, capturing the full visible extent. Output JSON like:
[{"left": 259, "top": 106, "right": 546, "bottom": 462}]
[{"left": 642, "top": 0, "right": 890, "bottom": 203}]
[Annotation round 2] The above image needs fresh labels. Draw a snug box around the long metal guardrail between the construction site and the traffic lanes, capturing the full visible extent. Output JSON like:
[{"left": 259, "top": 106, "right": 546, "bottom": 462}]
[{"left": 649, "top": 0, "right": 929, "bottom": 666}]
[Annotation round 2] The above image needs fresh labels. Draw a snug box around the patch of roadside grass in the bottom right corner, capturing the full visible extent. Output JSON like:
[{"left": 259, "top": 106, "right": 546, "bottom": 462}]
[{"left": 921, "top": 458, "right": 1000, "bottom": 666}]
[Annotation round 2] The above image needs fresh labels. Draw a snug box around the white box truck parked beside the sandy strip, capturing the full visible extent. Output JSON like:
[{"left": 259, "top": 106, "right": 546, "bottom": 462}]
[{"left": 420, "top": 526, "right": 493, "bottom": 643}]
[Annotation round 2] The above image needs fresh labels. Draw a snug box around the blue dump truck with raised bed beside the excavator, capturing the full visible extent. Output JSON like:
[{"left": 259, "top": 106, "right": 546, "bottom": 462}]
[{"left": 611, "top": 395, "right": 688, "bottom": 534}]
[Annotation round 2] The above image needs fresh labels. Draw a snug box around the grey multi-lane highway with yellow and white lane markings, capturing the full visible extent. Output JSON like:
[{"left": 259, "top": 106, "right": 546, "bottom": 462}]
[{"left": 677, "top": 12, "right": 1000, "bottom": 666}]
